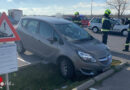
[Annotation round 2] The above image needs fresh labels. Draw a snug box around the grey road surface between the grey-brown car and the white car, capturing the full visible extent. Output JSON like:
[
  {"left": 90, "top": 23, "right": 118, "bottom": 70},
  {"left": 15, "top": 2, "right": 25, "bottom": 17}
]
[{"left": 86, "top": 29, "right": 130, "bottom": 60}]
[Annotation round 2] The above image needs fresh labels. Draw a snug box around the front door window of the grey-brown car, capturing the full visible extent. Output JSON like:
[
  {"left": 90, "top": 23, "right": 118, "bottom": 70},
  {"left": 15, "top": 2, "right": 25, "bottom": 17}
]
[{"left": 39, "top": 22, "right": 53, "bottom": 39}]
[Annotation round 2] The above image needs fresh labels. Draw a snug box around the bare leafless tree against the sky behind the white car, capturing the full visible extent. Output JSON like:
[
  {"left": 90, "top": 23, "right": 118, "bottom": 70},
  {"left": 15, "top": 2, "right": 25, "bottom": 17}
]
[{"left": 107, "top": 0, "right": 128, "bottom": 18}]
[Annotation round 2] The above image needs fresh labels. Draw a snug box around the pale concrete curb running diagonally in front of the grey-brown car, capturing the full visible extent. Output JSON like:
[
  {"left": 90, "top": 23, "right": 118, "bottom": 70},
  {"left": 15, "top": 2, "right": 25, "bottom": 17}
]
[{"left": 72, "top": 62, "right": 128, "bottom": 90}]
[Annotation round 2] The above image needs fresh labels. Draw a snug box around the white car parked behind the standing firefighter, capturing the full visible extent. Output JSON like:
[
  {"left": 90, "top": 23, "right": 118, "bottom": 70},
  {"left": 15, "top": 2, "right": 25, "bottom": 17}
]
[{"left": 89, "top": 17, "right": 129, "bottom": 36}]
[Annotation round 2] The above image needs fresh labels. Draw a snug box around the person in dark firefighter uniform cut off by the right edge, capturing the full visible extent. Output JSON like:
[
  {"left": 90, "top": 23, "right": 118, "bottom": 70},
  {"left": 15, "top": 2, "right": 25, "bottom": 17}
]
[{"left": 123, "top": 18, "right": 130, "bottom": 52}]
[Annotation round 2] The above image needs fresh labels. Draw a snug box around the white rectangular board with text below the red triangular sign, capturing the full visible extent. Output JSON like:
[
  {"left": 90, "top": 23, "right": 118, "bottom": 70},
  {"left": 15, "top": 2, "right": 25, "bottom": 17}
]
[{"left": 0, "top": 43, "right": 18, "bottom": 75}]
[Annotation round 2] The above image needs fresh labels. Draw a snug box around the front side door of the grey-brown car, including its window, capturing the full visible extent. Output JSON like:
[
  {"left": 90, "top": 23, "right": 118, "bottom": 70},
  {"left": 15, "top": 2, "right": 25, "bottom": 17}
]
[{"left": 37, "top": 21, "right": 59, "bottom": 60}]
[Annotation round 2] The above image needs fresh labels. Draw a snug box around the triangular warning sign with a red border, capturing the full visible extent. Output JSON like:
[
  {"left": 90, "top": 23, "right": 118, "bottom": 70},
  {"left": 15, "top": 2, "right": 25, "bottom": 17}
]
[{"left": 0, "top": 13, "right": 20, "bottom": 42}]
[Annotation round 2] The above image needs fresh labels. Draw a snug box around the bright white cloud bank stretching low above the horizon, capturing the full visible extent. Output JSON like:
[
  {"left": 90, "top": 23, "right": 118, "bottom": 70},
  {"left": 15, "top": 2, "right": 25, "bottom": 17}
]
[{"left": 0, "top": 2, "right": 128, "bottom": 15}]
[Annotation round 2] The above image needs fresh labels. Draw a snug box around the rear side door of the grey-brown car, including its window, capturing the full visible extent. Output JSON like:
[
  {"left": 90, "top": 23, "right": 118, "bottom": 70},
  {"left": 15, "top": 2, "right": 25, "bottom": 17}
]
[{"left": 21, "top": 19, "right": 39, "bottom": 52}]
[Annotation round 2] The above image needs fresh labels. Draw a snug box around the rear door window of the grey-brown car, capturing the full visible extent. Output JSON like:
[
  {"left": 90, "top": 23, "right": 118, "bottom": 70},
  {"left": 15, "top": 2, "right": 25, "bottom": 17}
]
[{"left": 26, "top": 20, "right": 39, "bottom": 33}]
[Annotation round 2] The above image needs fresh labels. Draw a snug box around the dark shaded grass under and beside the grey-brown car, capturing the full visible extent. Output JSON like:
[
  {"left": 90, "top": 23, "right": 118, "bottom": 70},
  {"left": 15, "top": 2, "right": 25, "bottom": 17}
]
[{"left": 0, "top": 60, "right": 121, "bottom": 90}]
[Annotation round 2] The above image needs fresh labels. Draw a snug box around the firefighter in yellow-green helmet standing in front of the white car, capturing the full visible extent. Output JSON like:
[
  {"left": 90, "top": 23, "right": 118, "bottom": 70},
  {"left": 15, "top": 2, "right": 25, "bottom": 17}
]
[{"left": 101, "top": 9, "right": 112, "bottom": 44}]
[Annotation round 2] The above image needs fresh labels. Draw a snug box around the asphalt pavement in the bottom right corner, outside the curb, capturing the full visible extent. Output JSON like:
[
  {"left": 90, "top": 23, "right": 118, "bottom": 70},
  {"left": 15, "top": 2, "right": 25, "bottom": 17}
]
[{"left": 90, "top": 67, "right": 130, "bottom": 90}]
